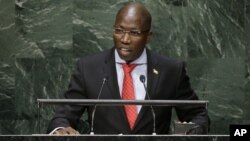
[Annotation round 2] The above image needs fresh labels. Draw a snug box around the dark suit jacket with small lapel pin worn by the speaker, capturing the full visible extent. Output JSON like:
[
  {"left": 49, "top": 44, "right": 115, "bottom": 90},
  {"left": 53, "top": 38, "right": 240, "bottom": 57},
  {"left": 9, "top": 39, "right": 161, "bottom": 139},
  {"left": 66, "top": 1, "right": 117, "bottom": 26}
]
[{"left": 48, "top": 48, "right": 208, "bottom": 134}]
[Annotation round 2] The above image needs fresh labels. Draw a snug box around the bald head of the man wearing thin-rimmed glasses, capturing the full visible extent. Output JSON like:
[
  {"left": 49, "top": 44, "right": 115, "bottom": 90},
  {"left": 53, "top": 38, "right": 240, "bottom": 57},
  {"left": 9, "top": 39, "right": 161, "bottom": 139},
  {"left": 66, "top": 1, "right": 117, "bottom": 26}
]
[{"left": 113, "top": 3, "right": 152, "bottom": 62}]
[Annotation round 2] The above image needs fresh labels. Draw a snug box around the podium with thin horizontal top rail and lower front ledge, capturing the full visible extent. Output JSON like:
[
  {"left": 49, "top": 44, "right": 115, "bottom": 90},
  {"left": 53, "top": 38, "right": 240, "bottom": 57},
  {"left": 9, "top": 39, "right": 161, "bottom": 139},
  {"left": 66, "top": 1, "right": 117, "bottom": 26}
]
[{"left": 13, "top": 99, "right": 229, "bottom": 141}]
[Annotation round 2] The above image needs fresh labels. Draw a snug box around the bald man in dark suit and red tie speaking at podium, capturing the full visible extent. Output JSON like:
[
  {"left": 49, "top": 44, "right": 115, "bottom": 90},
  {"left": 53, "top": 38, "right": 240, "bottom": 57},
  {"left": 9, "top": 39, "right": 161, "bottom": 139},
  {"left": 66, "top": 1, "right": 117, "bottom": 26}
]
[{"left": 48, "top": 3, "right": 209, "bottom": 134}]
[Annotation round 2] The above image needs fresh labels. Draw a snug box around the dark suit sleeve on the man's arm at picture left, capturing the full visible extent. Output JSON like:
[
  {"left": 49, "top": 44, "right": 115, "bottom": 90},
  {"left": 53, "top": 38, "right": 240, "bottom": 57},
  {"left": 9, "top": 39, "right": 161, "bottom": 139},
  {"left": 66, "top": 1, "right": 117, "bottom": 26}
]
[{"left": 47, "top": 61, "right": 87, "bottom": 133}]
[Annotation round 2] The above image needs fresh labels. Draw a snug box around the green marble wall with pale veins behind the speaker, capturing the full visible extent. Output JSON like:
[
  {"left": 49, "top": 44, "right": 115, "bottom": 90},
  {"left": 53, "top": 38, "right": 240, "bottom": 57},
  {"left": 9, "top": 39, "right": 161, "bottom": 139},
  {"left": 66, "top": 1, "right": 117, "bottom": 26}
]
[{"left": 0, "top": 0, "right": 250, "bottom": 134}]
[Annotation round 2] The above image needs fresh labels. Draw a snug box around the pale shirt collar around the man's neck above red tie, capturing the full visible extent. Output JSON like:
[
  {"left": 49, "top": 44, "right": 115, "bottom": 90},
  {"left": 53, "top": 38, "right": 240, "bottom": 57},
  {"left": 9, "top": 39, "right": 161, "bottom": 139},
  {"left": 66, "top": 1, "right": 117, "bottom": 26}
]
[{"left": 115, "top": 49, "right": 147, "bottom": 64}]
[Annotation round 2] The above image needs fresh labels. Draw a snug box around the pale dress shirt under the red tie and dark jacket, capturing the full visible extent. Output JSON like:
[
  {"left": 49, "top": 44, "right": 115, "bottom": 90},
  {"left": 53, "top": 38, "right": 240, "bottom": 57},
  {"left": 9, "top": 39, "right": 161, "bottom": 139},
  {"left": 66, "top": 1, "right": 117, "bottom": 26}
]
[{"left": 115, "top": 49, "right": 147, "bottom": 113}]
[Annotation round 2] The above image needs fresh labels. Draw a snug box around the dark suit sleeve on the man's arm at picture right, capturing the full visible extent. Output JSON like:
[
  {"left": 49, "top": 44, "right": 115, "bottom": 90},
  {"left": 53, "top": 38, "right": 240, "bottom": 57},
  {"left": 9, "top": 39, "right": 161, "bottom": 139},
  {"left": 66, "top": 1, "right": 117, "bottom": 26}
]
[{"left": 176, "top": 63, "right": 210, "bottom": 134}]
